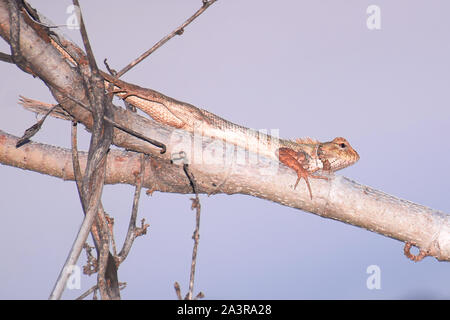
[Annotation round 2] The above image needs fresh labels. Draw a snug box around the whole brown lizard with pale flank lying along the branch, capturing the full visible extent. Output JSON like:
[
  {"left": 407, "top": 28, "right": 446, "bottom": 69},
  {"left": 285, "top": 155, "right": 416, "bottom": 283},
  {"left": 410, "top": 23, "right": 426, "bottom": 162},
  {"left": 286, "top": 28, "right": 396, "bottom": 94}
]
[{"left": 102, "top": 72, "right": 359, "bottom": 199}]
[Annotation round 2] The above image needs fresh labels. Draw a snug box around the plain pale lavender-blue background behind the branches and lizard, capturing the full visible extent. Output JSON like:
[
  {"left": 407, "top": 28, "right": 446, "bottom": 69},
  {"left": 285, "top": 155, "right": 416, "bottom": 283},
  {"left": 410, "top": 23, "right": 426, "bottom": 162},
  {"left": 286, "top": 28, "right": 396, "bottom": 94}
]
[{"left": 0, "top": 0, "right": 450, "bottom": 299}]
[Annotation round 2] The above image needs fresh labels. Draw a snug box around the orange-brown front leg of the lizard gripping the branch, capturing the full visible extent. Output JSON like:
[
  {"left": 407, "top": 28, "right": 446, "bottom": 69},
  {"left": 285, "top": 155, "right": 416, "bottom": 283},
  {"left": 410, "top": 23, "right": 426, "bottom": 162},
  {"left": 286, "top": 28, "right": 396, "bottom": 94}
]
[{"left": 277, "top": 148, "right": 328, "bottom": 200}]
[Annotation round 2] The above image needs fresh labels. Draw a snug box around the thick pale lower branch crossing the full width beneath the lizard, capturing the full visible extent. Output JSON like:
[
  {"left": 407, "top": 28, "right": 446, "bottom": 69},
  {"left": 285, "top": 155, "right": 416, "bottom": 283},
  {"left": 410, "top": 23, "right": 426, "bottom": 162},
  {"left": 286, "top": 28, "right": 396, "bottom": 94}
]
[{"left": 0, "top": 126, "right": 450, "bottom": 261}]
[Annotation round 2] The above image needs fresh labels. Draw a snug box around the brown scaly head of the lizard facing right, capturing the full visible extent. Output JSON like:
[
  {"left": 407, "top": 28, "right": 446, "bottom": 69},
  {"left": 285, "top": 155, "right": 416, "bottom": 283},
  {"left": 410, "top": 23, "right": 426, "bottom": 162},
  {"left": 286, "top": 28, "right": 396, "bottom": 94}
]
[{"left": 318, "top": 137, "right": 359, "bottom": 171}]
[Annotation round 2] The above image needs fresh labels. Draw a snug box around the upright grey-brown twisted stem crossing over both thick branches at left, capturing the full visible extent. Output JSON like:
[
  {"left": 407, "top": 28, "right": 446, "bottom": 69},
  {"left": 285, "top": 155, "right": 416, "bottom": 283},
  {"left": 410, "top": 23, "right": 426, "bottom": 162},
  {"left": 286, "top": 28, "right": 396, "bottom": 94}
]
[{"left": 50, "top": 0, "right": 118, "bottom": 299}]
